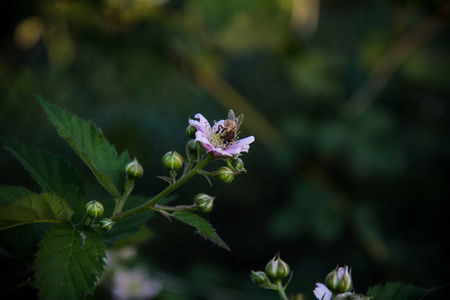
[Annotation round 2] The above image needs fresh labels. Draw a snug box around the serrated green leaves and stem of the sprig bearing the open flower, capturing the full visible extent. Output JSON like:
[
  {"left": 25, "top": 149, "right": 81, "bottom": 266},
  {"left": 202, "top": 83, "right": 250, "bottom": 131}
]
[{"left": 0, "top": 97, "right": 230, "bottom": 299}]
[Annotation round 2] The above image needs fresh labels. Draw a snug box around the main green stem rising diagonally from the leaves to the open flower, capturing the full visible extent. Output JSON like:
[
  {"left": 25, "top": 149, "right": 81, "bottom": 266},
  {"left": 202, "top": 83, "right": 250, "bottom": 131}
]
[{"left": 111, "top": 156, "right": 213, "bottom": 223}]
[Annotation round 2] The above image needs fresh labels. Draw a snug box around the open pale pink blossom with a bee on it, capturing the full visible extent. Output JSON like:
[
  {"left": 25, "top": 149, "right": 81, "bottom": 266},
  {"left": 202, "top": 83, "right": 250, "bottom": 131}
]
[{"left": 189, "top": 113, "right": 255, "bottom": 157}]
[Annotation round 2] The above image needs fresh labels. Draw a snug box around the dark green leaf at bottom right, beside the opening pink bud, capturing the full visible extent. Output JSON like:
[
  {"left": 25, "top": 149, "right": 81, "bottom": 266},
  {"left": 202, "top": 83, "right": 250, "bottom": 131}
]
[{"left": 367, "top": 282, "right": 426, "bottom": 300}]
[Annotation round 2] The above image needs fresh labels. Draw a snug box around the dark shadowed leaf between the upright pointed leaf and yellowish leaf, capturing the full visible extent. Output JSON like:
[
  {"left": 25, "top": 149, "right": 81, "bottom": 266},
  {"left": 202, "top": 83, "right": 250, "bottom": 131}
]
[{"left": 2, "top": 139, "right": 87, "bottom": 221}]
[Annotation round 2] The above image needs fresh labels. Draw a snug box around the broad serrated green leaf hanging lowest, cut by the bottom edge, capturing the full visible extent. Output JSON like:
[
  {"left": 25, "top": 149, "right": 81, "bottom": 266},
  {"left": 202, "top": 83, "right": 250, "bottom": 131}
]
[{"left": 34, "top": 224, "right": 106, "bottom": 299}]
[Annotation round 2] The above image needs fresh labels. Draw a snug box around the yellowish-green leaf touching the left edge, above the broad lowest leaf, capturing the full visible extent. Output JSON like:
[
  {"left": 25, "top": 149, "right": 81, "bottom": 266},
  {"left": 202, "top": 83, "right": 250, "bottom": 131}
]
[{"left": 0, "top": 193, "right": 73, "bottom": 229}]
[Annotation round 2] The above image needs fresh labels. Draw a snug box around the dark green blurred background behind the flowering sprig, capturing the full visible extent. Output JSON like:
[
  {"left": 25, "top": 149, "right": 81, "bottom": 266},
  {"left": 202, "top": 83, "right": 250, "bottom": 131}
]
[{"left": 0, "top": 0, "right": 450, "bottom": 300}]
